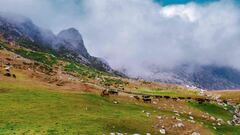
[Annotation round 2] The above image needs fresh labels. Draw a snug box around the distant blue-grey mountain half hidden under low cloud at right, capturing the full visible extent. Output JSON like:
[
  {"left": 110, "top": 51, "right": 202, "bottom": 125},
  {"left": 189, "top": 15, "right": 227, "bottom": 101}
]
[{"left": 147, "top": 65, "right": 240, "bottom": 90}]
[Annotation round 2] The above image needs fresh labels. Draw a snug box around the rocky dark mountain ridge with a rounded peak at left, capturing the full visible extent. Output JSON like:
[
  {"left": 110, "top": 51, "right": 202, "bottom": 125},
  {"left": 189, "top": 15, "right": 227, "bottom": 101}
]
[{"left": 0, "top": 13, "right": 115, "bottom": 74}]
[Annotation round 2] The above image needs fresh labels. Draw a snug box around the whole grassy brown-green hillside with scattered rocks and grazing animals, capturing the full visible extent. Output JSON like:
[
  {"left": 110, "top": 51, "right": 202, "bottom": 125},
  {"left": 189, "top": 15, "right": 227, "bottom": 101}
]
[{"left": 0, "top": 37, "right": 240, "bottom": 135}]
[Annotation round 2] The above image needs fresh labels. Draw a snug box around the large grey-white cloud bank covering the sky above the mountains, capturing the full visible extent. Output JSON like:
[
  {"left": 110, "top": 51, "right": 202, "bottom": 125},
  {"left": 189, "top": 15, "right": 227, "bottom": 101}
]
[{"left": 0, "top": 0, "right": 240, "bottom": 76}]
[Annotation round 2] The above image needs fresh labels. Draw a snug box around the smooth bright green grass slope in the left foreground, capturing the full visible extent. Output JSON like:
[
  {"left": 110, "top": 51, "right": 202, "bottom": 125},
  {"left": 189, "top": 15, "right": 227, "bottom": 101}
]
[{"left": 0, "top": 76, "right": 161, "bottom": 134}]
